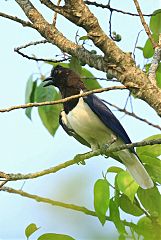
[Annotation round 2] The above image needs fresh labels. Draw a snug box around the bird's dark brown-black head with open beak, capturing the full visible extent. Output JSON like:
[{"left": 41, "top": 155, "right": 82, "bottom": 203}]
[{"left": 44, "top": 65, "right": 85, "bottom": 93}]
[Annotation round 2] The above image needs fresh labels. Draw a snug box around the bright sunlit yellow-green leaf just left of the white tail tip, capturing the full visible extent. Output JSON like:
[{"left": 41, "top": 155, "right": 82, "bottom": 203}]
[{"left": 116, "top": 171, "right": 139, "bottom": 202}]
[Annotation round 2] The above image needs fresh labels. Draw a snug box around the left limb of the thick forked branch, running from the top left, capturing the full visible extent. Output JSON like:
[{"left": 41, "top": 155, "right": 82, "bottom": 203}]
[{"left": 16, "top": 0, "right": 107, "bottom": 71}]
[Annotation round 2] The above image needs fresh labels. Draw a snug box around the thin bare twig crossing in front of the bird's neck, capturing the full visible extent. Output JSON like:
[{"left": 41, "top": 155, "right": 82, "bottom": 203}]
[{"left": 0, "top": 86, "right": 128, "bottom": 113}]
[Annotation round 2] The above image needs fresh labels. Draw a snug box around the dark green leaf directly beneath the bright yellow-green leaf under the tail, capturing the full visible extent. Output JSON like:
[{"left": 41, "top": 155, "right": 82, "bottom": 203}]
[{"left": 119, "top": 194, "right": 144, "bottom": 216}]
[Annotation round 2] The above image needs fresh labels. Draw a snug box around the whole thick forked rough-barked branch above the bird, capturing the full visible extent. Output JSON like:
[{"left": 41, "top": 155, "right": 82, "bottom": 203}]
[{"left": 1, "top": 0, "right": 161, "bottom": 116}]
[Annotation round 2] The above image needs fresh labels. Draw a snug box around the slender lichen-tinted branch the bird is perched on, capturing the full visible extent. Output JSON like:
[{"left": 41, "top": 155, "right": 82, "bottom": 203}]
[{"left": 0, "top": 139, "right": 161, "bottom": 181}]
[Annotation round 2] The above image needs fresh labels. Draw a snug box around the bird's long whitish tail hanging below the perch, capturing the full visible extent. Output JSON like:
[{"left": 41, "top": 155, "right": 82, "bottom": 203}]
[{"left": 119, "top": 149, "right": 154, "bottom": 189}]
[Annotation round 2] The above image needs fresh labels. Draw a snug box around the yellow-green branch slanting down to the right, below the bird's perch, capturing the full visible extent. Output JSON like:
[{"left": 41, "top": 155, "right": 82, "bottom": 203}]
[{"left": 0, "top": 187, "right": 135, "bottom": 226}]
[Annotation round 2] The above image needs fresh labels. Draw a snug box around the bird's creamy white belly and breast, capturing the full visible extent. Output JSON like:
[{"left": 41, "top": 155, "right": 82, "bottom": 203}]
[{"left": 67, "top": 98, "right": 115, "bottom": 149}]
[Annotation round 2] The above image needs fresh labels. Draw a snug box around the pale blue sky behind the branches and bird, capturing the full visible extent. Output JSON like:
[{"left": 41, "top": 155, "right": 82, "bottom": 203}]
[{"left": 0, "top": 0, "right": 161, "bottom": 240}]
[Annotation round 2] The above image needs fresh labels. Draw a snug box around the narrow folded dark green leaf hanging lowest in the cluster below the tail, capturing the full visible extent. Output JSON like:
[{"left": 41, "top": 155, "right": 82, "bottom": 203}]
[{"left": 109, "top": 198, "right": 126, "bottom": 235}]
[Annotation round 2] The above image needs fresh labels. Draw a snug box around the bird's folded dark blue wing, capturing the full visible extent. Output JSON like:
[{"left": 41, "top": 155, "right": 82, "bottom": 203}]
[{"left": 84, "top": 94, "right": 131, "bottom": 144}]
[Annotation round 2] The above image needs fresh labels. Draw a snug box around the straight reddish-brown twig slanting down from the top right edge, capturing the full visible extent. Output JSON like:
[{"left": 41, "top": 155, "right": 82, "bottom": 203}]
[{"left": 133, "top": 0, "right": 157, "bottom": 48}]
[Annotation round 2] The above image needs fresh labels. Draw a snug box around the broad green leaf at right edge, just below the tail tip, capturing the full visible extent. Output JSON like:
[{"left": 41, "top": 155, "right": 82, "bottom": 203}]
[{"left": 137, "top": 187, "right": 161, "bottom": 219}]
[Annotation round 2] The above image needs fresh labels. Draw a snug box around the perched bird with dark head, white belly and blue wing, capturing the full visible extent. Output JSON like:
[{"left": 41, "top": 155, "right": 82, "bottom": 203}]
[{"left": 44, "top": 65, "right": 154, "bottom": 189}]
